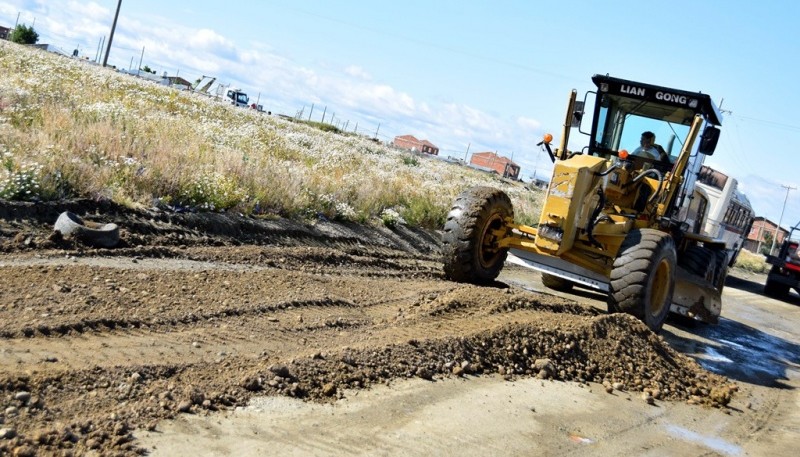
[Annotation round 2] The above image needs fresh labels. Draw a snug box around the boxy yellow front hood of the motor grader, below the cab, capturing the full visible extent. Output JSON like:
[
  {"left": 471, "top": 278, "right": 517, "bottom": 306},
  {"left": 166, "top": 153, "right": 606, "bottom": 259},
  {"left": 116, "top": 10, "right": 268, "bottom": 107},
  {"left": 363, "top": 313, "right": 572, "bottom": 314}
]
[{"left": 536, "top": 155, "right": 608, "bottom": 255}]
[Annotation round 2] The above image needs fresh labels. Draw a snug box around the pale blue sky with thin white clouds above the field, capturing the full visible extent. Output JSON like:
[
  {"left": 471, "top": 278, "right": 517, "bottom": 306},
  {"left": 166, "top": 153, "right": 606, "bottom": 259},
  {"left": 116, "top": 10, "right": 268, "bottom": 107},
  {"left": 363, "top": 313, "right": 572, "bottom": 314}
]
[{"left": 0, "top": 0, "right": 800, "bottom": 232}]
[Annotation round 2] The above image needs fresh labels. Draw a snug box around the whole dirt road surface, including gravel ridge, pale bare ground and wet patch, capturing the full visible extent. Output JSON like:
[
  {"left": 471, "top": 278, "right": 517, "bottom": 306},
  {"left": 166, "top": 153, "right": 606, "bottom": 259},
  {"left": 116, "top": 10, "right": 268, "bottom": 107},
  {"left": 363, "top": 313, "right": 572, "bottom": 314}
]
[{"left": 0, "top": 202, "right": 800, "bottom": 455}]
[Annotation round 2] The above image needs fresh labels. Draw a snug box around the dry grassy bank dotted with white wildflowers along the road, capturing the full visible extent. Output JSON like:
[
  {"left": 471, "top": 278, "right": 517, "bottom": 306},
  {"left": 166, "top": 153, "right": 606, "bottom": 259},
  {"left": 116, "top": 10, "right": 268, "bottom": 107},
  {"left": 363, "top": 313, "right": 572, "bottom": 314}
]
[{"left": 0, "top": 42, "right": 542, "bottom": 228}]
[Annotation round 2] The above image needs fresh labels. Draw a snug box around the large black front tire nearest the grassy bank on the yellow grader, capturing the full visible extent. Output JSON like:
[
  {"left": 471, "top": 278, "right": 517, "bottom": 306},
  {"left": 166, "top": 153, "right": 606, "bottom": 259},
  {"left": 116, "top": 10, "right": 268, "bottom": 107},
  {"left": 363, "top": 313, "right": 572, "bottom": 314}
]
[{"left": 442, "top": 187, "right": 514, "bottom": 284}]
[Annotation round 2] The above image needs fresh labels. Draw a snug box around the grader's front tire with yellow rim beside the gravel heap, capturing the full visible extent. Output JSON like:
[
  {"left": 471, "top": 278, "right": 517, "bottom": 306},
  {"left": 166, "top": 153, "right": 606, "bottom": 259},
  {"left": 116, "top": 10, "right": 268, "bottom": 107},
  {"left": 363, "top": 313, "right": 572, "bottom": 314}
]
[{"left": 608, "top": 229, "right": 677, "bottom": 332}]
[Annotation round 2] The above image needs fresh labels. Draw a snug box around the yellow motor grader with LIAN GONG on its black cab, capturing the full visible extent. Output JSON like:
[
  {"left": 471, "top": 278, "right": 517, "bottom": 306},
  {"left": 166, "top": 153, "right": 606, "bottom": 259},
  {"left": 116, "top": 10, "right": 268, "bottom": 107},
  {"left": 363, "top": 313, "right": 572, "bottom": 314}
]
[{"left": 442, "top": 75, "right": 728, "bottom": 332}]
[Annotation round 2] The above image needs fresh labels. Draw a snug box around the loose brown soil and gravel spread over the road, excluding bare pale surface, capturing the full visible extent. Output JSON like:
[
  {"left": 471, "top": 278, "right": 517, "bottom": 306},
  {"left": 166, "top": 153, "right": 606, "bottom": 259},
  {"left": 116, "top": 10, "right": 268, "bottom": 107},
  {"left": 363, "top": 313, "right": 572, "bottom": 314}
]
[{"left": 0, "top": 207, "right": 744, "bottom": 455}]
